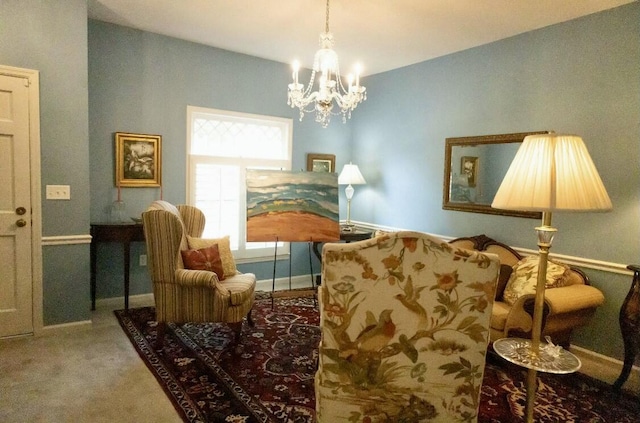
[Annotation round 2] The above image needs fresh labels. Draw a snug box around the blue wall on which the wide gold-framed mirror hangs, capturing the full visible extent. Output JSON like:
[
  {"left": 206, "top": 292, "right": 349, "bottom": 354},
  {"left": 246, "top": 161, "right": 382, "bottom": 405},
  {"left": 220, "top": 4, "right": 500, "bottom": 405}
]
[{"left": 352, "top": 2, "right": 640, "bottom": 357}]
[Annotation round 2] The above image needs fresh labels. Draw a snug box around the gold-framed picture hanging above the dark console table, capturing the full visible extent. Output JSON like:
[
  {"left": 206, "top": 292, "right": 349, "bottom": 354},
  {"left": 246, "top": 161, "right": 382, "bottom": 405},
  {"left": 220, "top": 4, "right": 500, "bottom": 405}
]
[{"left": 115, "top": 132, "right": 162, "bottom": 187}]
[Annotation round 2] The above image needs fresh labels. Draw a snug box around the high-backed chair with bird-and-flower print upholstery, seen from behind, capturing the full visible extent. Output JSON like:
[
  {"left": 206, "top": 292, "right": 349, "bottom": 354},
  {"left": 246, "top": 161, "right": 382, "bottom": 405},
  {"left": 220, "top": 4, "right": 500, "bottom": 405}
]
[{"left": 315, "top": 232, "right": 500, "bottom": 423}]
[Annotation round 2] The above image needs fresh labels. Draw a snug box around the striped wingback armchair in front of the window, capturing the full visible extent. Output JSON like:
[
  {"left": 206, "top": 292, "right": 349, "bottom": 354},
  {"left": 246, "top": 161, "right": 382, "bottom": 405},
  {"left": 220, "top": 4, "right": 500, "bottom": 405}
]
[{"left": 142, "top": 201, "right": 256, "bottom": 348}]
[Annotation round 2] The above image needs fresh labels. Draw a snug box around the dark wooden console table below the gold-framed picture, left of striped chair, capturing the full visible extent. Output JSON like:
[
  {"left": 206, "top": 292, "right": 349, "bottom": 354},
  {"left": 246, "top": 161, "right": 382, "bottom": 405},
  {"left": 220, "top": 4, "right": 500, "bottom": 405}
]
[{"left": 91, "top": 222, "right": 144, "bottom": 310}]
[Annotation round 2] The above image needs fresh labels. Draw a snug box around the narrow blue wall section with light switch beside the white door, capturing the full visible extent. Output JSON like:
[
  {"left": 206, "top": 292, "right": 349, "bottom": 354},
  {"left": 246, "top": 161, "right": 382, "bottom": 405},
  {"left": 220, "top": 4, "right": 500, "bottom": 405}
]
[{"left": 0, "top": 0, "right": 90, "bottom": 325}]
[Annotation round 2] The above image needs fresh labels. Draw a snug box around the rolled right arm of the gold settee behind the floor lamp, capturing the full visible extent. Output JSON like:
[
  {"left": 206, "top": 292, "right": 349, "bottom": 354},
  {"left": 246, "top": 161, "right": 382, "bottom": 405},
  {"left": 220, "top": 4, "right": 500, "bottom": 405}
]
[{"left": 544, "top": 285, "right": 604, "bottom": 315}]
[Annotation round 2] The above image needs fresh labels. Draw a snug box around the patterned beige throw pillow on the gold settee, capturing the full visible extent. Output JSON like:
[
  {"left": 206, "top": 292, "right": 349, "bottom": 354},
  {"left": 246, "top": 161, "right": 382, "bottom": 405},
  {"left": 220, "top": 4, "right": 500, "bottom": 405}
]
[{"left": 503, "top": 256, "right": 569, "bottom": 305}]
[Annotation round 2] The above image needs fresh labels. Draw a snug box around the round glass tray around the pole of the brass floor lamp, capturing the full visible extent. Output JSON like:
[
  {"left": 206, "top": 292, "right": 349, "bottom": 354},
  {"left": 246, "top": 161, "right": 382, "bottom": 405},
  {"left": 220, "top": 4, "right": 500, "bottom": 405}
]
[{"left": 493, "top": 338, "right": 582, "bottom": 374}]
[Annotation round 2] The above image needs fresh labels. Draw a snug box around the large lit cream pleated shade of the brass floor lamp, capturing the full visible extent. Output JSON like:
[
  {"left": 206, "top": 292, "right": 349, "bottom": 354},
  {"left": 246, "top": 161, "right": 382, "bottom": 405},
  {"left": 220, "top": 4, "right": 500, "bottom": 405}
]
[{"left": 491, "top": 133, "right": 612, "bottom": 212}]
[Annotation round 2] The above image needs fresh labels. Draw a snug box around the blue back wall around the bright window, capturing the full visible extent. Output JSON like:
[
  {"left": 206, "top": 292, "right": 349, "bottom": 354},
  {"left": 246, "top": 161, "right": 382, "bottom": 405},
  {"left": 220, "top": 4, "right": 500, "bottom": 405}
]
[{"left": 89, "top": 20, "right": 351, "bottom": 298}]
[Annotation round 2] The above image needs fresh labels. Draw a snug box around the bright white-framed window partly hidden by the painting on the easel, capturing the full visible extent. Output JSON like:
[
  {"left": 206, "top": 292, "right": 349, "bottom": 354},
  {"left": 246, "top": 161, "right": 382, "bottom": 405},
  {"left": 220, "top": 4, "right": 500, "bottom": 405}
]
[{"left": 187, "top": 106, "right": 293, "bottom": 261}]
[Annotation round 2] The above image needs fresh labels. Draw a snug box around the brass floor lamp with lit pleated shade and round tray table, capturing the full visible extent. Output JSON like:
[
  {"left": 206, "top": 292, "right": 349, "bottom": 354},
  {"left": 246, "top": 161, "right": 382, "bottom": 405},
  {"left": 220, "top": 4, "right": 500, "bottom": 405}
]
[{"left": 491, "top": 133, "right": 612, "bottom": 422}]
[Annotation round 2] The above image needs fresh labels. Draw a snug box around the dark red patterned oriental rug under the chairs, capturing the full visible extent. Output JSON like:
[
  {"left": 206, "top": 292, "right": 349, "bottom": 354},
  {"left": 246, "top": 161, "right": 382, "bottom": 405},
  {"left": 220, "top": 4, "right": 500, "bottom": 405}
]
[{"left": 115, "top": 293, "right": 640, "bottom": 423}]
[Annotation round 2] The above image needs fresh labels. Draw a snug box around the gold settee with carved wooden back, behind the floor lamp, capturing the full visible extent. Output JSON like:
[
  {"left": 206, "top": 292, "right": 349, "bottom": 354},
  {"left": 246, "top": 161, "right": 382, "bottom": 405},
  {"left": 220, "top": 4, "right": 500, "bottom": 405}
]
[{"left": 450, "top": 235, "right": 604, "bottom": 348}]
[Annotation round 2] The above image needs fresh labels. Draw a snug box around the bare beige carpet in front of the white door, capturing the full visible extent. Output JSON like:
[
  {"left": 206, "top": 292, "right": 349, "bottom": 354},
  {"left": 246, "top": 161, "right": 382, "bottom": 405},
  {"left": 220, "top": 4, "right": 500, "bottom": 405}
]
[{"left": 0, "top": 296, "right": 182, "bottom": 423}]
